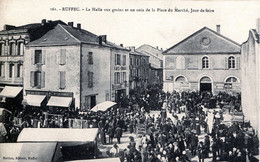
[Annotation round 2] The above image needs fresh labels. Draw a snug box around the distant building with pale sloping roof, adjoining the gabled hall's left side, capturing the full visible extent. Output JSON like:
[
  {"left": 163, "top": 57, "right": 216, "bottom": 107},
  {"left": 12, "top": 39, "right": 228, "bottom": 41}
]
[{"left": 136, "top": 44, "right": 163, "bottom": 86}]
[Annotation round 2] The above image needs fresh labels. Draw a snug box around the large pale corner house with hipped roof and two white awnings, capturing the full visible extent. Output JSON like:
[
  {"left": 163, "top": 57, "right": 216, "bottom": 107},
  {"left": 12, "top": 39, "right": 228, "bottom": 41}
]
[{"left": 24, "top": 22, "right": 129, "bottom": 110}]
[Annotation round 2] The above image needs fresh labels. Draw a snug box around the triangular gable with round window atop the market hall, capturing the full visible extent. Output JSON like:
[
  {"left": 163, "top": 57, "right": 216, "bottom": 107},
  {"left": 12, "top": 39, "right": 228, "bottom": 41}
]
[{"left": 163, "top": 27, "right": 240, "bottom": 54}]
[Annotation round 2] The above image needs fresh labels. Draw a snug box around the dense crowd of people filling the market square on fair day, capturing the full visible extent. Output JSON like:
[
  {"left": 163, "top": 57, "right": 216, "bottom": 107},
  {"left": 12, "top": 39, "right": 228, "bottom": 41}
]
[{"left": 0, "top": 86, "right": 259, "bottom": 162}]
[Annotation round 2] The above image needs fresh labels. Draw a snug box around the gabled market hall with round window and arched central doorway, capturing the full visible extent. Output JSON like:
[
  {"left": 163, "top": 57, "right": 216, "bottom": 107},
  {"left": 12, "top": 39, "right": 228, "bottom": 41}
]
[{"left": 163, "top": 25, "right": 241, "bottom": 94}]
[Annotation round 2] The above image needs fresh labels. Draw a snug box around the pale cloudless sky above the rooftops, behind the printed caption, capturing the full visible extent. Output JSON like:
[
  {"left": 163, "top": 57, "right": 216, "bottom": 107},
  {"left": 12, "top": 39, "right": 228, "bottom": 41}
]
[{"left": 0, "top": 0, "right": 260, "bottom": 50}]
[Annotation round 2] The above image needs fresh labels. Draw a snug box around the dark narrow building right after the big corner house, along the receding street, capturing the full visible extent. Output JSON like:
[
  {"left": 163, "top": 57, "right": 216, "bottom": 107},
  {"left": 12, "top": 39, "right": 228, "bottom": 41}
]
[{"left": 129, "top": 47, "right": 149, "bottom": 90}]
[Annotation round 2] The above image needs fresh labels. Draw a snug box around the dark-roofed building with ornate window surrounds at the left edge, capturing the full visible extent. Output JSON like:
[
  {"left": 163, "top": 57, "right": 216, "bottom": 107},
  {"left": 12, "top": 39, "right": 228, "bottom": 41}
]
[{"left": 0, "top": 19, "right": 64, "bottom": 109}]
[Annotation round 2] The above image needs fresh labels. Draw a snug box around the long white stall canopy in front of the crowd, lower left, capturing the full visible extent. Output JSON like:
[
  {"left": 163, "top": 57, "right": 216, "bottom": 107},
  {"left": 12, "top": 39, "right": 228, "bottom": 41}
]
[{"left": 17, "top": 128, "right": 98, "bottom": 142}]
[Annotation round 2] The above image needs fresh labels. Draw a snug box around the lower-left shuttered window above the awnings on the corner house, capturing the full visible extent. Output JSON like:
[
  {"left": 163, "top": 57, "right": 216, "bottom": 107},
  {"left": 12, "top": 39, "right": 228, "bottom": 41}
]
[{"left": 30, "top": 71, "right": 45, "bottom": 88}]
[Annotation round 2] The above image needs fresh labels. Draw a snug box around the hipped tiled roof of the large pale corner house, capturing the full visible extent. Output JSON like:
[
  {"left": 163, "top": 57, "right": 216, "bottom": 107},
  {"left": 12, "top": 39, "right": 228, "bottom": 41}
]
[{"left": 28, "top": 24, "right": 127, "bottom": 50}]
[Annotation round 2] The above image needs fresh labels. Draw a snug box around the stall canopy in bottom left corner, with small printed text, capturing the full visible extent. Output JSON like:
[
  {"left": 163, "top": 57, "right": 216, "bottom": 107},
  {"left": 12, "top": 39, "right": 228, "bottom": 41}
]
[{"left": 0, "top": 143, "right": 61, "bottom": 162}]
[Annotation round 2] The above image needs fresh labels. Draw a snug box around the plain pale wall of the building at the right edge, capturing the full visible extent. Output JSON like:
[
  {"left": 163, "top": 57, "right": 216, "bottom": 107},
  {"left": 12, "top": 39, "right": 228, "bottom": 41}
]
[{"left": 241, "top": 19, "right": 260, "bottom": 134}]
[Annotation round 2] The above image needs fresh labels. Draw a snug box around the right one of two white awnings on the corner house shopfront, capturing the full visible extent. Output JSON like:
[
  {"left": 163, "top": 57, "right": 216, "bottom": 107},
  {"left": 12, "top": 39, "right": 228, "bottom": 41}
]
[{"left": 47, "top": 96, "right": 72, "bottom": 107}]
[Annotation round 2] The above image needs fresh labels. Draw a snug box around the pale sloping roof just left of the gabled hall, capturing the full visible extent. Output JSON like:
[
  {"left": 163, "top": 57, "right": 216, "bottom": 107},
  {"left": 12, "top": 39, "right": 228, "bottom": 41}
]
[{"left": 136, "top": 44, "right": 163, "bottom": 59}]
